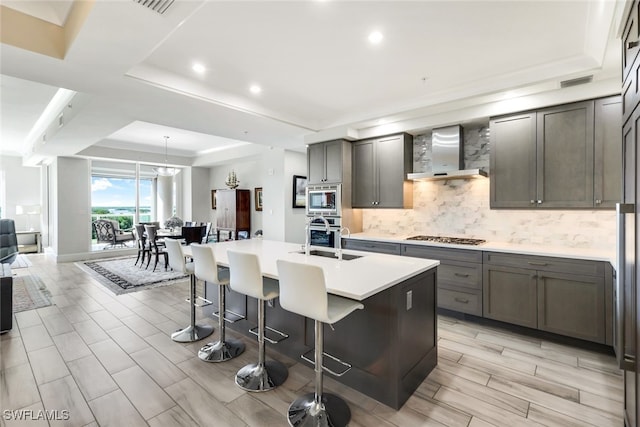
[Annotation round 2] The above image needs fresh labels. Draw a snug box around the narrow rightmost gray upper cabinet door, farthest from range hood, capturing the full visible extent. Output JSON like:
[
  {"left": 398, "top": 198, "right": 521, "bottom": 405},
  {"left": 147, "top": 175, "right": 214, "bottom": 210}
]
[{"left": 593, "top": 96, "right": 622, "bottom": 208}]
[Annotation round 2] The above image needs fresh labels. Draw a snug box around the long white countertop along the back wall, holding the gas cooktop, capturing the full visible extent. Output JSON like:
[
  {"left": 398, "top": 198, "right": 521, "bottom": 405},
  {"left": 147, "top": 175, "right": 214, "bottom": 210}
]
[{"left": 349, "top": 233, "right": 616, "bottom": 266}]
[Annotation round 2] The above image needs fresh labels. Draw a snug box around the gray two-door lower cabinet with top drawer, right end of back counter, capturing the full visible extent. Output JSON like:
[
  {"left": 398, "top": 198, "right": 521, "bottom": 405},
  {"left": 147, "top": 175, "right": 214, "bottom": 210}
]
[{"left": 483, "top": 252, "right": 612, "bottom": 344}]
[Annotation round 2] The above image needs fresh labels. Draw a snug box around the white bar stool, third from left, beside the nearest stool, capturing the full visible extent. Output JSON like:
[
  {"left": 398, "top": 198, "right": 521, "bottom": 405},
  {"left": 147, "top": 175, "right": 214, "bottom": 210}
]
[{"left": 227, "top": 251, "right": 289, "bottom": 391}]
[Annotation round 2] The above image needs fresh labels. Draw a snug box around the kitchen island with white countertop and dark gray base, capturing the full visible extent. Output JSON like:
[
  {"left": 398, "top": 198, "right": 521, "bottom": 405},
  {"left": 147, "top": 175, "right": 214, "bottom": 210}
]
[{"left": 185, "top": 239, "right": 439, "bottom": 409}]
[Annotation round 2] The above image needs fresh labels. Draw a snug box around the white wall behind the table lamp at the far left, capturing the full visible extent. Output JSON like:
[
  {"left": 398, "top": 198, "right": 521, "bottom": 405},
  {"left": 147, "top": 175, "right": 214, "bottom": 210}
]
[{"left": 0, "top": 156, "right": 42, "bottom": 230}]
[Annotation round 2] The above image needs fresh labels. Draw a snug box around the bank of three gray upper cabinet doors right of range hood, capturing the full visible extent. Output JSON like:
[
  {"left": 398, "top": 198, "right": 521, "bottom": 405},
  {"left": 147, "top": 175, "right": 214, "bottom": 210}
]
[{"left": 491, "top": 97, "right": 622, "bottom": 209}]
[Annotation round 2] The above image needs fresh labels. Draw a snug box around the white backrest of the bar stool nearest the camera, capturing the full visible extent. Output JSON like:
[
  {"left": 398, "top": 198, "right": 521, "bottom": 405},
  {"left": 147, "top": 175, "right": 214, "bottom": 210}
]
[{"left": 278, "top": 260, "right": 332, "bottom": 323}]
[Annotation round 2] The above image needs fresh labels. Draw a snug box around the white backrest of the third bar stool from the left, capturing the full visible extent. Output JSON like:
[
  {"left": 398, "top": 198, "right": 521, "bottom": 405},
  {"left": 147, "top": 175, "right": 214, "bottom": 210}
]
[{"left": 227, "top": 251, "right": 268, "bottom": 299}]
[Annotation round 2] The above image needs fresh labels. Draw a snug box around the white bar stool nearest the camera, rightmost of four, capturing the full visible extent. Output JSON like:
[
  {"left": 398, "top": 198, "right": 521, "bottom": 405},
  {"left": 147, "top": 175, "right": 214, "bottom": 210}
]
[{"left": 278, "top": 260, "right": 364, "bottom": 427}]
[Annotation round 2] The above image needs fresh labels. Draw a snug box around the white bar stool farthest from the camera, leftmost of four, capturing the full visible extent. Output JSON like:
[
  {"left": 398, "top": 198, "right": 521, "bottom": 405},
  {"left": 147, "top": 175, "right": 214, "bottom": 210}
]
[{"left": 165, "top": 239, "right": 213, "bottom": 342}]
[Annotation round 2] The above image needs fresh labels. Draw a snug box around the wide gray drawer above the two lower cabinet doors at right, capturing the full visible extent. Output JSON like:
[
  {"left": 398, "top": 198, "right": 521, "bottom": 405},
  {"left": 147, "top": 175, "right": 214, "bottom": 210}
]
[{"left": 484, "top": 252, "right": 604, "bottom": 276}]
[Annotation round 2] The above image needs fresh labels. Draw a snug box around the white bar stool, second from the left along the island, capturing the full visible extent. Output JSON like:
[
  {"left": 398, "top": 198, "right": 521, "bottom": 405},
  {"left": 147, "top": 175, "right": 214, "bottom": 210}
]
[{"left": 191, "top": 243, "right": 245, "bottom": 362}]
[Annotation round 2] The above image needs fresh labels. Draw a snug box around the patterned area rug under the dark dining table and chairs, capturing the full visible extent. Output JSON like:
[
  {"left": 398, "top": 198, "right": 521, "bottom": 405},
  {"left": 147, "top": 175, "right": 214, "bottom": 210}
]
[{"left": 76, "top": 257, "right": 187, "bottom": 295}]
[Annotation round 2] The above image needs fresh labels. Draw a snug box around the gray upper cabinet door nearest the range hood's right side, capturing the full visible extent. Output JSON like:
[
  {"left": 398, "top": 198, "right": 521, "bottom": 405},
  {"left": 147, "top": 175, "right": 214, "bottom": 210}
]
[{"left": 490, "top": 112, "right": 536, "bottom": 208}]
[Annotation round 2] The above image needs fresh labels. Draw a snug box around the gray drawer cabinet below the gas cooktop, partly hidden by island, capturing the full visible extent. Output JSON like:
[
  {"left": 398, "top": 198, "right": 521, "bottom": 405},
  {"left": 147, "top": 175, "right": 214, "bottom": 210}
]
[{"left": 402, "top": 245, "right": 482, "bottom": 316}]
